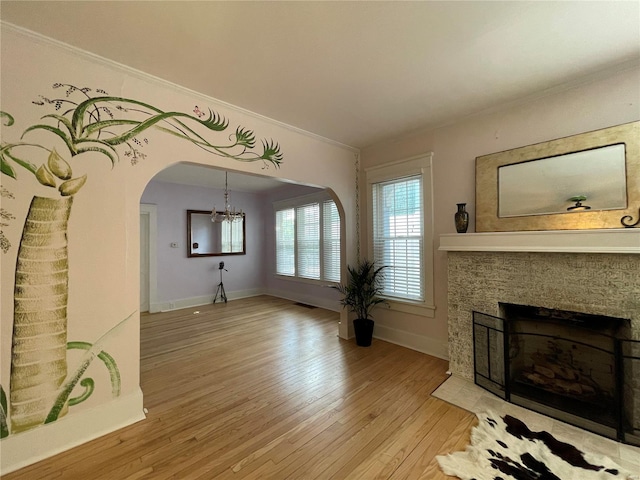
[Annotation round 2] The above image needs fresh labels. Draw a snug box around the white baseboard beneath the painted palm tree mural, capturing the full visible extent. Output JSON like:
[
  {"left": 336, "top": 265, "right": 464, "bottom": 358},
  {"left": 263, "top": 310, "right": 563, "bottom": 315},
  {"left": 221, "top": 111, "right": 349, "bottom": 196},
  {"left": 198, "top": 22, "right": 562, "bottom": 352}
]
[{"left": 0, "top": 388, "right": 146, "bottom": 476}]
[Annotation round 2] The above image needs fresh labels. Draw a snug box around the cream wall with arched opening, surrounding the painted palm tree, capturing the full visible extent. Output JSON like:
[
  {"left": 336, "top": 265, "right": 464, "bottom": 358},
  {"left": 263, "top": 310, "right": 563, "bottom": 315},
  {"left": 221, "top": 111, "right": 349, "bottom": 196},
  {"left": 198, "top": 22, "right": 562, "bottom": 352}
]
[{"left": 0, "top": 24, "right": 356, "bottom": 473}]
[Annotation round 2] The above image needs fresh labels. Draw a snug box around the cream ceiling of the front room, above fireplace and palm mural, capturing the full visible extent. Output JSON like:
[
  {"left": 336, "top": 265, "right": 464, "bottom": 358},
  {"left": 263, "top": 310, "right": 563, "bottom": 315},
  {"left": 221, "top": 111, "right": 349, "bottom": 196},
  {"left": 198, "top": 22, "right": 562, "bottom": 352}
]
[{"left": 0, "top": 0, "right": 640, "bottom": 189}]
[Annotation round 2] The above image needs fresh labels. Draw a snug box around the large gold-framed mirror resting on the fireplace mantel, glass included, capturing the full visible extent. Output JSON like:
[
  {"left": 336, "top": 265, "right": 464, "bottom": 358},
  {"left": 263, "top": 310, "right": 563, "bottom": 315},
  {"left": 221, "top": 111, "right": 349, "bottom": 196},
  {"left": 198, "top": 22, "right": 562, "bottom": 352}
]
[{"left": 476, "top": 122, "right": 640, "bottom": 232}]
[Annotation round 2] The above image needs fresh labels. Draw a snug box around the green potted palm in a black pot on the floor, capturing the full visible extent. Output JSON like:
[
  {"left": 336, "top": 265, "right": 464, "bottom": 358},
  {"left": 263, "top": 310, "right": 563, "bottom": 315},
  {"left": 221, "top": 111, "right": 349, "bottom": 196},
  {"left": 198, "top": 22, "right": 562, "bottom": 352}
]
[{"left": 335, "top": 259, "right": 387, "bottom": 347}]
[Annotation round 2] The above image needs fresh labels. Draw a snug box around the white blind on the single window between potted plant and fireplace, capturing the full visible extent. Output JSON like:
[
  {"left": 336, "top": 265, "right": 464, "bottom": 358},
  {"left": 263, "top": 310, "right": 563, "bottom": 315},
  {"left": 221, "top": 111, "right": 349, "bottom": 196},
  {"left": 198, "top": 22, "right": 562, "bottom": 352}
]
[{"left": 372, "top": 175, "right": 424, "bottom": 301}]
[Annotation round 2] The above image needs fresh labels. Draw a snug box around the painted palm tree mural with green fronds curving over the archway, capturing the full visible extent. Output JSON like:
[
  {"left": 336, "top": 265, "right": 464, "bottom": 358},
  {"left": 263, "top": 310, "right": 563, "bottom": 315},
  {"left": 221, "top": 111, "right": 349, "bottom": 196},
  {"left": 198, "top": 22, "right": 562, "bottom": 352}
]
[{"left": 0, "top": 83, "right": 282, "bottom": 437}]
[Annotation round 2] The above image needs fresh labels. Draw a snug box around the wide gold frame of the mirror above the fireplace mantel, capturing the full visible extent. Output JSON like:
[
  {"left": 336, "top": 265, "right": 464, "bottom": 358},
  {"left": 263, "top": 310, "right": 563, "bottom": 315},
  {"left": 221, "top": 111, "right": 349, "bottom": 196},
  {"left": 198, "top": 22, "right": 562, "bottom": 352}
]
[{"left": 476, "top": 121, "right": 640, "bottom": 232}]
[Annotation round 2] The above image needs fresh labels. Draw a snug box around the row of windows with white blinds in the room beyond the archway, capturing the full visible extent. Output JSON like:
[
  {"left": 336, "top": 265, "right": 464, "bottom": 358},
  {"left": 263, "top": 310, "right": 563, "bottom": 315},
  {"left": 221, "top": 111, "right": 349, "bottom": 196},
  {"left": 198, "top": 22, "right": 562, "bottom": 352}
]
[{"left": 275, "top": 197, "right": 340, "bottom": 282}]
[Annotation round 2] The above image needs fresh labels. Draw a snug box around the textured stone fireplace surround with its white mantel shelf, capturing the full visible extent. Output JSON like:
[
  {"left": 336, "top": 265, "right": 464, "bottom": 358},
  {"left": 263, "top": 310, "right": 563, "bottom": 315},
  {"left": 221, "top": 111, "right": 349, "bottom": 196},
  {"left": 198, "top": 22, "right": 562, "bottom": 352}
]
[{"left": 440, "top": 229, "right": 640, "bottom": 444}]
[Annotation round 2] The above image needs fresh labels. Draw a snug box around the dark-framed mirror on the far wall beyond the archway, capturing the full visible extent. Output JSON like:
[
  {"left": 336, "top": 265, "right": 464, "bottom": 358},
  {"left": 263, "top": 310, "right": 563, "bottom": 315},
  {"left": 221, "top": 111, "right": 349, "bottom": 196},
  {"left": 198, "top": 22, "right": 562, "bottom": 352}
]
[{"left": 187, "top": 210, "right": 247, "bottom": 257}]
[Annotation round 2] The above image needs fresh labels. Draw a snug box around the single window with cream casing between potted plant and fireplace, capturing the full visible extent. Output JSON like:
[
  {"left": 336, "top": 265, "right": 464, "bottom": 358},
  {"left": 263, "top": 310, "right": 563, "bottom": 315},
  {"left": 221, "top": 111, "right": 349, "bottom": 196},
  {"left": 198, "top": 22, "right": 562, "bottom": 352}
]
[{"left": 366, "top": 154, "right": 435, "bottom": 316}]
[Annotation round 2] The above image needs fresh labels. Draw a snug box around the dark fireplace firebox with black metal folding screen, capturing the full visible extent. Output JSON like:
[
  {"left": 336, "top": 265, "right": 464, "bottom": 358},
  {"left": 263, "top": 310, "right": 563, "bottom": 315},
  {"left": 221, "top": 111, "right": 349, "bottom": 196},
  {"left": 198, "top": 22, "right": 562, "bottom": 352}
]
[{"left": 473, "top": 303, "right": 640, "bottom": 446}]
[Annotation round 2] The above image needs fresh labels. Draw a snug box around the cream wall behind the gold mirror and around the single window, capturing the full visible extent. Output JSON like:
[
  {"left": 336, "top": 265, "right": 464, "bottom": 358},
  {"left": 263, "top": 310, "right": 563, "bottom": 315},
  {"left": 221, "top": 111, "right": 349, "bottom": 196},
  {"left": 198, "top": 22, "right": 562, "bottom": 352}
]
[{"left": 361, "top": 68, "right": 640, "bottom": 357}]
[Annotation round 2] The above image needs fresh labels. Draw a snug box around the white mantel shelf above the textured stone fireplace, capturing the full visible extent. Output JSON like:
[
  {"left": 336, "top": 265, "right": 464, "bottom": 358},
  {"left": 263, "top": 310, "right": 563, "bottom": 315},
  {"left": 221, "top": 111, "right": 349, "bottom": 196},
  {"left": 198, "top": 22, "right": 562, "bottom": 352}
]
[{"left": 439, "top": 228, "right": 640, "bottom": 255}]
